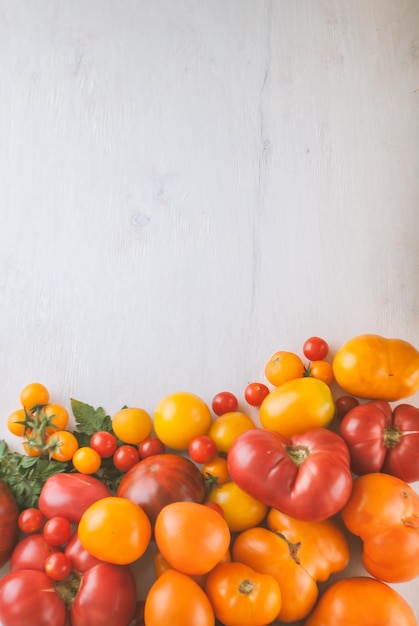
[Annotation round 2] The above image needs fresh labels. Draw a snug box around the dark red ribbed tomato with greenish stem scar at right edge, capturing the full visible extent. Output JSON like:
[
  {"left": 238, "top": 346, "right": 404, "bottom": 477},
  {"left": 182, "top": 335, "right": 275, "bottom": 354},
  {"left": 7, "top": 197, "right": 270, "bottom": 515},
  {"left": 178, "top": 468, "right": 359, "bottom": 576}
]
[{"left": 339, "top": 400, "right": 419, "bottom": 483}]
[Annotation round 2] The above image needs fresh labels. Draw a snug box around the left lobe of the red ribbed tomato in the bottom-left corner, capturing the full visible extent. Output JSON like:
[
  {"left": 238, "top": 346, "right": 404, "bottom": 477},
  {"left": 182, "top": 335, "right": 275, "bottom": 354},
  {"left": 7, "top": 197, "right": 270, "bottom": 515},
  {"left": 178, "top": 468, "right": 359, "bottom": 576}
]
[{"left": 0, "top": 569, "right": 67, "bottom": 626}]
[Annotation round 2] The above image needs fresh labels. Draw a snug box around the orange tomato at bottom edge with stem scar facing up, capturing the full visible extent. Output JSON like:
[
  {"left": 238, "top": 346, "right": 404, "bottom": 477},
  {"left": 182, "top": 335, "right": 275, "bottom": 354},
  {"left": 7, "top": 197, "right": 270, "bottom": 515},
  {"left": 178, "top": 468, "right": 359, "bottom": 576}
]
[{"left": 205, "top": 563, "right": 281, "bottom": 626}]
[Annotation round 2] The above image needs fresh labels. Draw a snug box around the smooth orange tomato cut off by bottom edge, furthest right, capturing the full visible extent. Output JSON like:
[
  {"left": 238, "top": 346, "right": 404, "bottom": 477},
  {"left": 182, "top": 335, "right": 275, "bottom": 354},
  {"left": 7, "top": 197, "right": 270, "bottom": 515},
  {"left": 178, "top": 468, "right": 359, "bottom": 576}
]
[{"left": 304, "top": 576, "right": 417, "bottom": 626}]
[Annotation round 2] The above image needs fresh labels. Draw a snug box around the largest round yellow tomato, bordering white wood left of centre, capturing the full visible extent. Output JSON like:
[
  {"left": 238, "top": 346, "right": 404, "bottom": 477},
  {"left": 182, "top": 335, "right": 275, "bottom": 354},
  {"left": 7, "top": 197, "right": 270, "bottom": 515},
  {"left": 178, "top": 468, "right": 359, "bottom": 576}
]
[{"left": 154, "top": 391, "right": 211, "bottom": 450}]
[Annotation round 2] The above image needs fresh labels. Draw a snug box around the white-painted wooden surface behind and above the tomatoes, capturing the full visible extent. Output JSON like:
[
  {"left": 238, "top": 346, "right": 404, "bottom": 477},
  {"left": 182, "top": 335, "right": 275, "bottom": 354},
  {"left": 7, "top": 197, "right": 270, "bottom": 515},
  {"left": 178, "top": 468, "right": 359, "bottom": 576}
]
[{"left": 0, "top": 0, "right": 419, "bottom": 615}]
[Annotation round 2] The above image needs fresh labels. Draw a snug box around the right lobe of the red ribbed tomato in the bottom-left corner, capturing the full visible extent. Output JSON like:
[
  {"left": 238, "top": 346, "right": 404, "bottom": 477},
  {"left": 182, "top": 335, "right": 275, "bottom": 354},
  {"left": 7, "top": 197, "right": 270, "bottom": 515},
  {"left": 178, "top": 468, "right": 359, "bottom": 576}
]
[{"left": 71, "top": 563, "right": 137, "bottom": 626}]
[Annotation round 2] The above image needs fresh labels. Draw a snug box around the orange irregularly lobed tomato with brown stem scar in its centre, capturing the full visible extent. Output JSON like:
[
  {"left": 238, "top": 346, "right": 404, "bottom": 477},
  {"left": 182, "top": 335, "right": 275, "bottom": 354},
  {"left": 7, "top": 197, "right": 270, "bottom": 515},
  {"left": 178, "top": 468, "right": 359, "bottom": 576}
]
[{"left": 236, "top": 509, "right": 349, "bottom": 623}]
